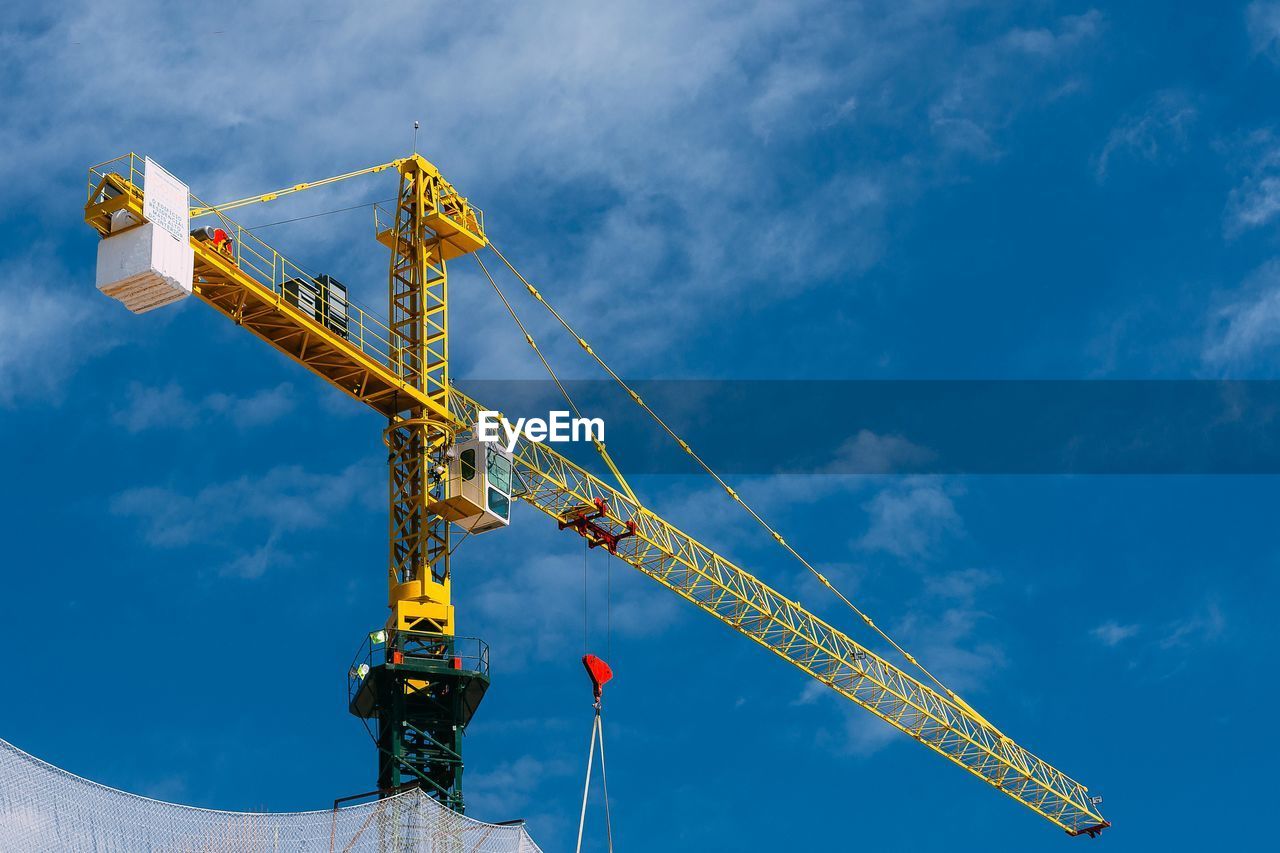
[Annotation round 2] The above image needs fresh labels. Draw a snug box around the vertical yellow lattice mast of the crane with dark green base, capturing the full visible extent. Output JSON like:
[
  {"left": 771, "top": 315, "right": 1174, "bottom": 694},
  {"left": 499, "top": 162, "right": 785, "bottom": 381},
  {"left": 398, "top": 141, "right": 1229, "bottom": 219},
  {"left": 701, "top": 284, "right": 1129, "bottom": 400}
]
[{"left": 366, "top": 154, "right": 488, "bottom": 812}]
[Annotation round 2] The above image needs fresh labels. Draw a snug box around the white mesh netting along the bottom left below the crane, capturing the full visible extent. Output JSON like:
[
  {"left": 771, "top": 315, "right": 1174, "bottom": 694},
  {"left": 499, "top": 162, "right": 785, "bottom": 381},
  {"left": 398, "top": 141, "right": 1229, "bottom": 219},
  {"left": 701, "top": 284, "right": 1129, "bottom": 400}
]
[{"left": 0, "top": 740, "right": 540, "bottom": 853}]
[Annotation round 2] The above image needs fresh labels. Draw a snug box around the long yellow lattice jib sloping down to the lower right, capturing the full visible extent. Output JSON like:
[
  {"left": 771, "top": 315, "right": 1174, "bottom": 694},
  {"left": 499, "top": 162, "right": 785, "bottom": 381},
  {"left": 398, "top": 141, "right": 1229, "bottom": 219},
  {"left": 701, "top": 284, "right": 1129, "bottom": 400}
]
[{"left": 452, "top": 389, "right": 1102, "bottom": 834}]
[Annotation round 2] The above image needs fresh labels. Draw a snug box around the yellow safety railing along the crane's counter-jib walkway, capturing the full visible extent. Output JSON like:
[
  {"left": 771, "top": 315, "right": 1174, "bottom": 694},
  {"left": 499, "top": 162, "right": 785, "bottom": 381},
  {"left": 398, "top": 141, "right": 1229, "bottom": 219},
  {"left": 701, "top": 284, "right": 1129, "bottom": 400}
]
[{"left": 88, "top": 152, "right": 440, "bottom": 393}]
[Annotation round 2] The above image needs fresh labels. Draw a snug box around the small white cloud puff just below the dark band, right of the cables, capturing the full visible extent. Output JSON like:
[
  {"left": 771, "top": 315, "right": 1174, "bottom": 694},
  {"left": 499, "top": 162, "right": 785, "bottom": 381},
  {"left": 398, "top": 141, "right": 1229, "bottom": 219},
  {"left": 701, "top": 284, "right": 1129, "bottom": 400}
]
[{"left": 860, "top": 476, "right": 964, "bottom": 558}]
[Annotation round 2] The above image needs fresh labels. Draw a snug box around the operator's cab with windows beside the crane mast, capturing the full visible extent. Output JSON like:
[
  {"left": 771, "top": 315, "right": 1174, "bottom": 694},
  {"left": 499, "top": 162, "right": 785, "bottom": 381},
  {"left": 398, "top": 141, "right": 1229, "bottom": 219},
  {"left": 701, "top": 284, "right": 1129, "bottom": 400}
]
[{"left": 428, "top": 433, "right": 515, "bottom": 533}]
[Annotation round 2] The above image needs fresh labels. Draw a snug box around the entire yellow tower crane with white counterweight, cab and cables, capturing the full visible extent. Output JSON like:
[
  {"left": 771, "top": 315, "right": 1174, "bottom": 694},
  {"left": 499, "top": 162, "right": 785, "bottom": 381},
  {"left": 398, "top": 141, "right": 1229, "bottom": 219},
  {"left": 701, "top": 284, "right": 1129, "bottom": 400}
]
[{"left": 84, "top": 154, "right": 1110, "bottom": 836}]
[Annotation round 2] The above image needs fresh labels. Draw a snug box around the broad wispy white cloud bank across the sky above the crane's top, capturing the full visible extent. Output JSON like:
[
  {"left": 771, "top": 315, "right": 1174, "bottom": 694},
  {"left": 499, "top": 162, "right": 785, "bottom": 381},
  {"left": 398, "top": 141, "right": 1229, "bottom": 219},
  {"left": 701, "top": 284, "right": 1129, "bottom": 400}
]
[{"left": 0, "top": 0, "right": 1098, "bottom": 379}]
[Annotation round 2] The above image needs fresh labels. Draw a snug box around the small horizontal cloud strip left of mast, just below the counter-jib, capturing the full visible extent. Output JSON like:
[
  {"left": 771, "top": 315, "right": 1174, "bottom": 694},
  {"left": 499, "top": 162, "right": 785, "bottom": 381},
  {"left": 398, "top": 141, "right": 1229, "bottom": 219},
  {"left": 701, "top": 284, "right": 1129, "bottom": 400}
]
[{"left": 111, "top": 382, "right": 297, "bottom": 433}]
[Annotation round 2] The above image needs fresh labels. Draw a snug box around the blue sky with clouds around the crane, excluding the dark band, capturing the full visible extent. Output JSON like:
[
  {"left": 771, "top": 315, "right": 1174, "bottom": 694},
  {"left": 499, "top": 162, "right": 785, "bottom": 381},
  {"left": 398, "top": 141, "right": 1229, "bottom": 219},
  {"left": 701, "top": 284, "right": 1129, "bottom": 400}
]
[{"left": 0, "top": 0, "right": 1280, "bottom": 850}]
